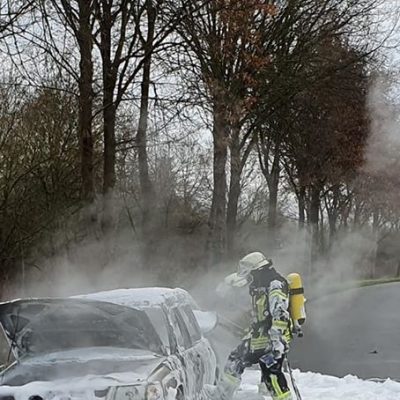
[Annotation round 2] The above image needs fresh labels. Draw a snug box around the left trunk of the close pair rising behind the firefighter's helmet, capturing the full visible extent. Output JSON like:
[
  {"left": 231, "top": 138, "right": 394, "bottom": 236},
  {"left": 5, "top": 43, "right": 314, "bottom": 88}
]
[{"left": 207, "top": 101, "right": 228, "bottom": 266}]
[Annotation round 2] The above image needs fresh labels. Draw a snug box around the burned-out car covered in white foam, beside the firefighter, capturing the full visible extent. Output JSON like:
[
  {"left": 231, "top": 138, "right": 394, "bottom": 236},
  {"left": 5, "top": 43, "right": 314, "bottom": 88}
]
[{"left": 0, "top": 288, "right": 216, "bottom": 400}]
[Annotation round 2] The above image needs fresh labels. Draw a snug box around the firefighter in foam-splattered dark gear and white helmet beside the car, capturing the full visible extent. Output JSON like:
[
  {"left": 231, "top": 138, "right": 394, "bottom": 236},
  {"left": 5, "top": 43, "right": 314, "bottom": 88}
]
[{"left": 205, "top": 252, "right": 295, "bottom": 400}]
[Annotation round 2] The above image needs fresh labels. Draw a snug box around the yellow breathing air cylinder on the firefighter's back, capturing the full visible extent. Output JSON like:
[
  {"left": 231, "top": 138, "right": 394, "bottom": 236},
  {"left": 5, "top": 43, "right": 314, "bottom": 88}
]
[{"left": 287, "top": 273, "right": 306, "bottom": 336}]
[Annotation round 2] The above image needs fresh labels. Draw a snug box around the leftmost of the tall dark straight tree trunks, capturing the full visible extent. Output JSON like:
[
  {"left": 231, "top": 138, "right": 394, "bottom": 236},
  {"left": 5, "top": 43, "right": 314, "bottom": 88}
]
[{"left": 77, "top": 0, "right": 94, "bottom": 203}]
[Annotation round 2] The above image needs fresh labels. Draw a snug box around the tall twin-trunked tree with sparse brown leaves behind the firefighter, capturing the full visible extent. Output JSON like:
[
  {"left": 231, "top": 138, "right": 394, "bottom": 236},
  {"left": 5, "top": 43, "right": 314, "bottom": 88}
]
[{"left": 180, "top": 0, "right": 276, "bottom": 264}]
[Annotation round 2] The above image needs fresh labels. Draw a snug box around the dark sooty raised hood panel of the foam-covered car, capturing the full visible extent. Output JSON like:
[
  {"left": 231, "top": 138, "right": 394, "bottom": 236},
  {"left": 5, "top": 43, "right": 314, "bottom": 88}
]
[{"left": 0, "top": 299, "right": 164, "bottom": 360}]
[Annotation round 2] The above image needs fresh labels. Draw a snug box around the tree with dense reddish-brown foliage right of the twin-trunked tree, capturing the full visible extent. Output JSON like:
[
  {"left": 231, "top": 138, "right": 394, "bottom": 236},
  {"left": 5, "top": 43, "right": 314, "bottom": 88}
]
[{"left": 283, "top": 40, "right": 368, "bottom": 266}]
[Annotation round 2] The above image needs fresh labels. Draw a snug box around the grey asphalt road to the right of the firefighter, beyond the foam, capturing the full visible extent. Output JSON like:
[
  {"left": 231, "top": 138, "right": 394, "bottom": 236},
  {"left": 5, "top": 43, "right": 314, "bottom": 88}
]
[{"left": 290, "top": 283, "right": 400, "bottom": 380}]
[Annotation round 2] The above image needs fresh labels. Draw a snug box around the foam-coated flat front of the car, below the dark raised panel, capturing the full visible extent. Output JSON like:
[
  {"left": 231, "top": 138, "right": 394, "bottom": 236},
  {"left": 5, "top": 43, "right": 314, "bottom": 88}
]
[{"left": 0, "top": 347, "right": 165, "bottom": 388}]
